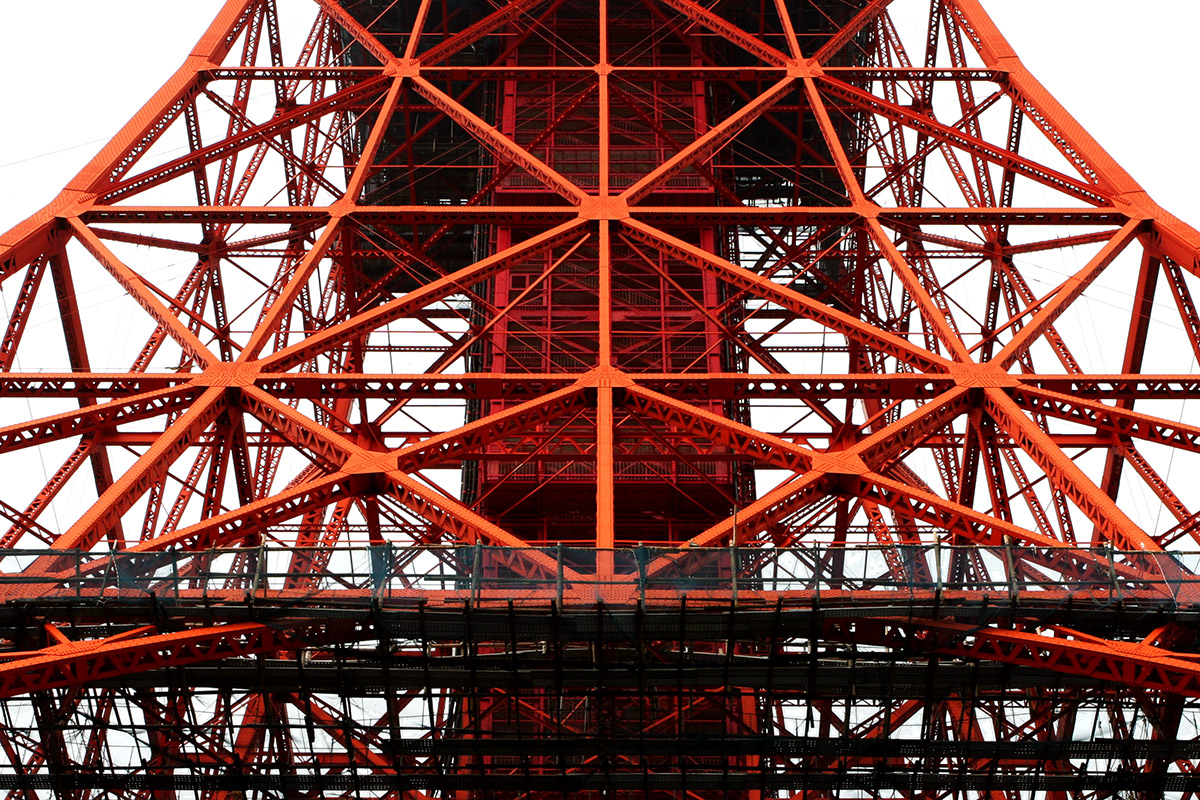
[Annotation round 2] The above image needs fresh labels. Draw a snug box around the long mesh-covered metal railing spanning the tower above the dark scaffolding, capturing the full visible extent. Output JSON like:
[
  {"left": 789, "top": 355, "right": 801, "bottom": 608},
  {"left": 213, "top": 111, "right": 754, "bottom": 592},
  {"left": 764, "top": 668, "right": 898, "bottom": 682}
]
[{"left": 0, "top": 545, "right": 1200, "bottom": 609}]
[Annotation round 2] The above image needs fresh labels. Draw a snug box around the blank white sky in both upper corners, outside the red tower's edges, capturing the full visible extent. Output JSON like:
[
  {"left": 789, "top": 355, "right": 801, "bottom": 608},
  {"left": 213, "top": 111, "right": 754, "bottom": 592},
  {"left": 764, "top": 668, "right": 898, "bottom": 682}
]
[{"left": 0, "top": 0, "right": 1200, "bottom": 230}]
